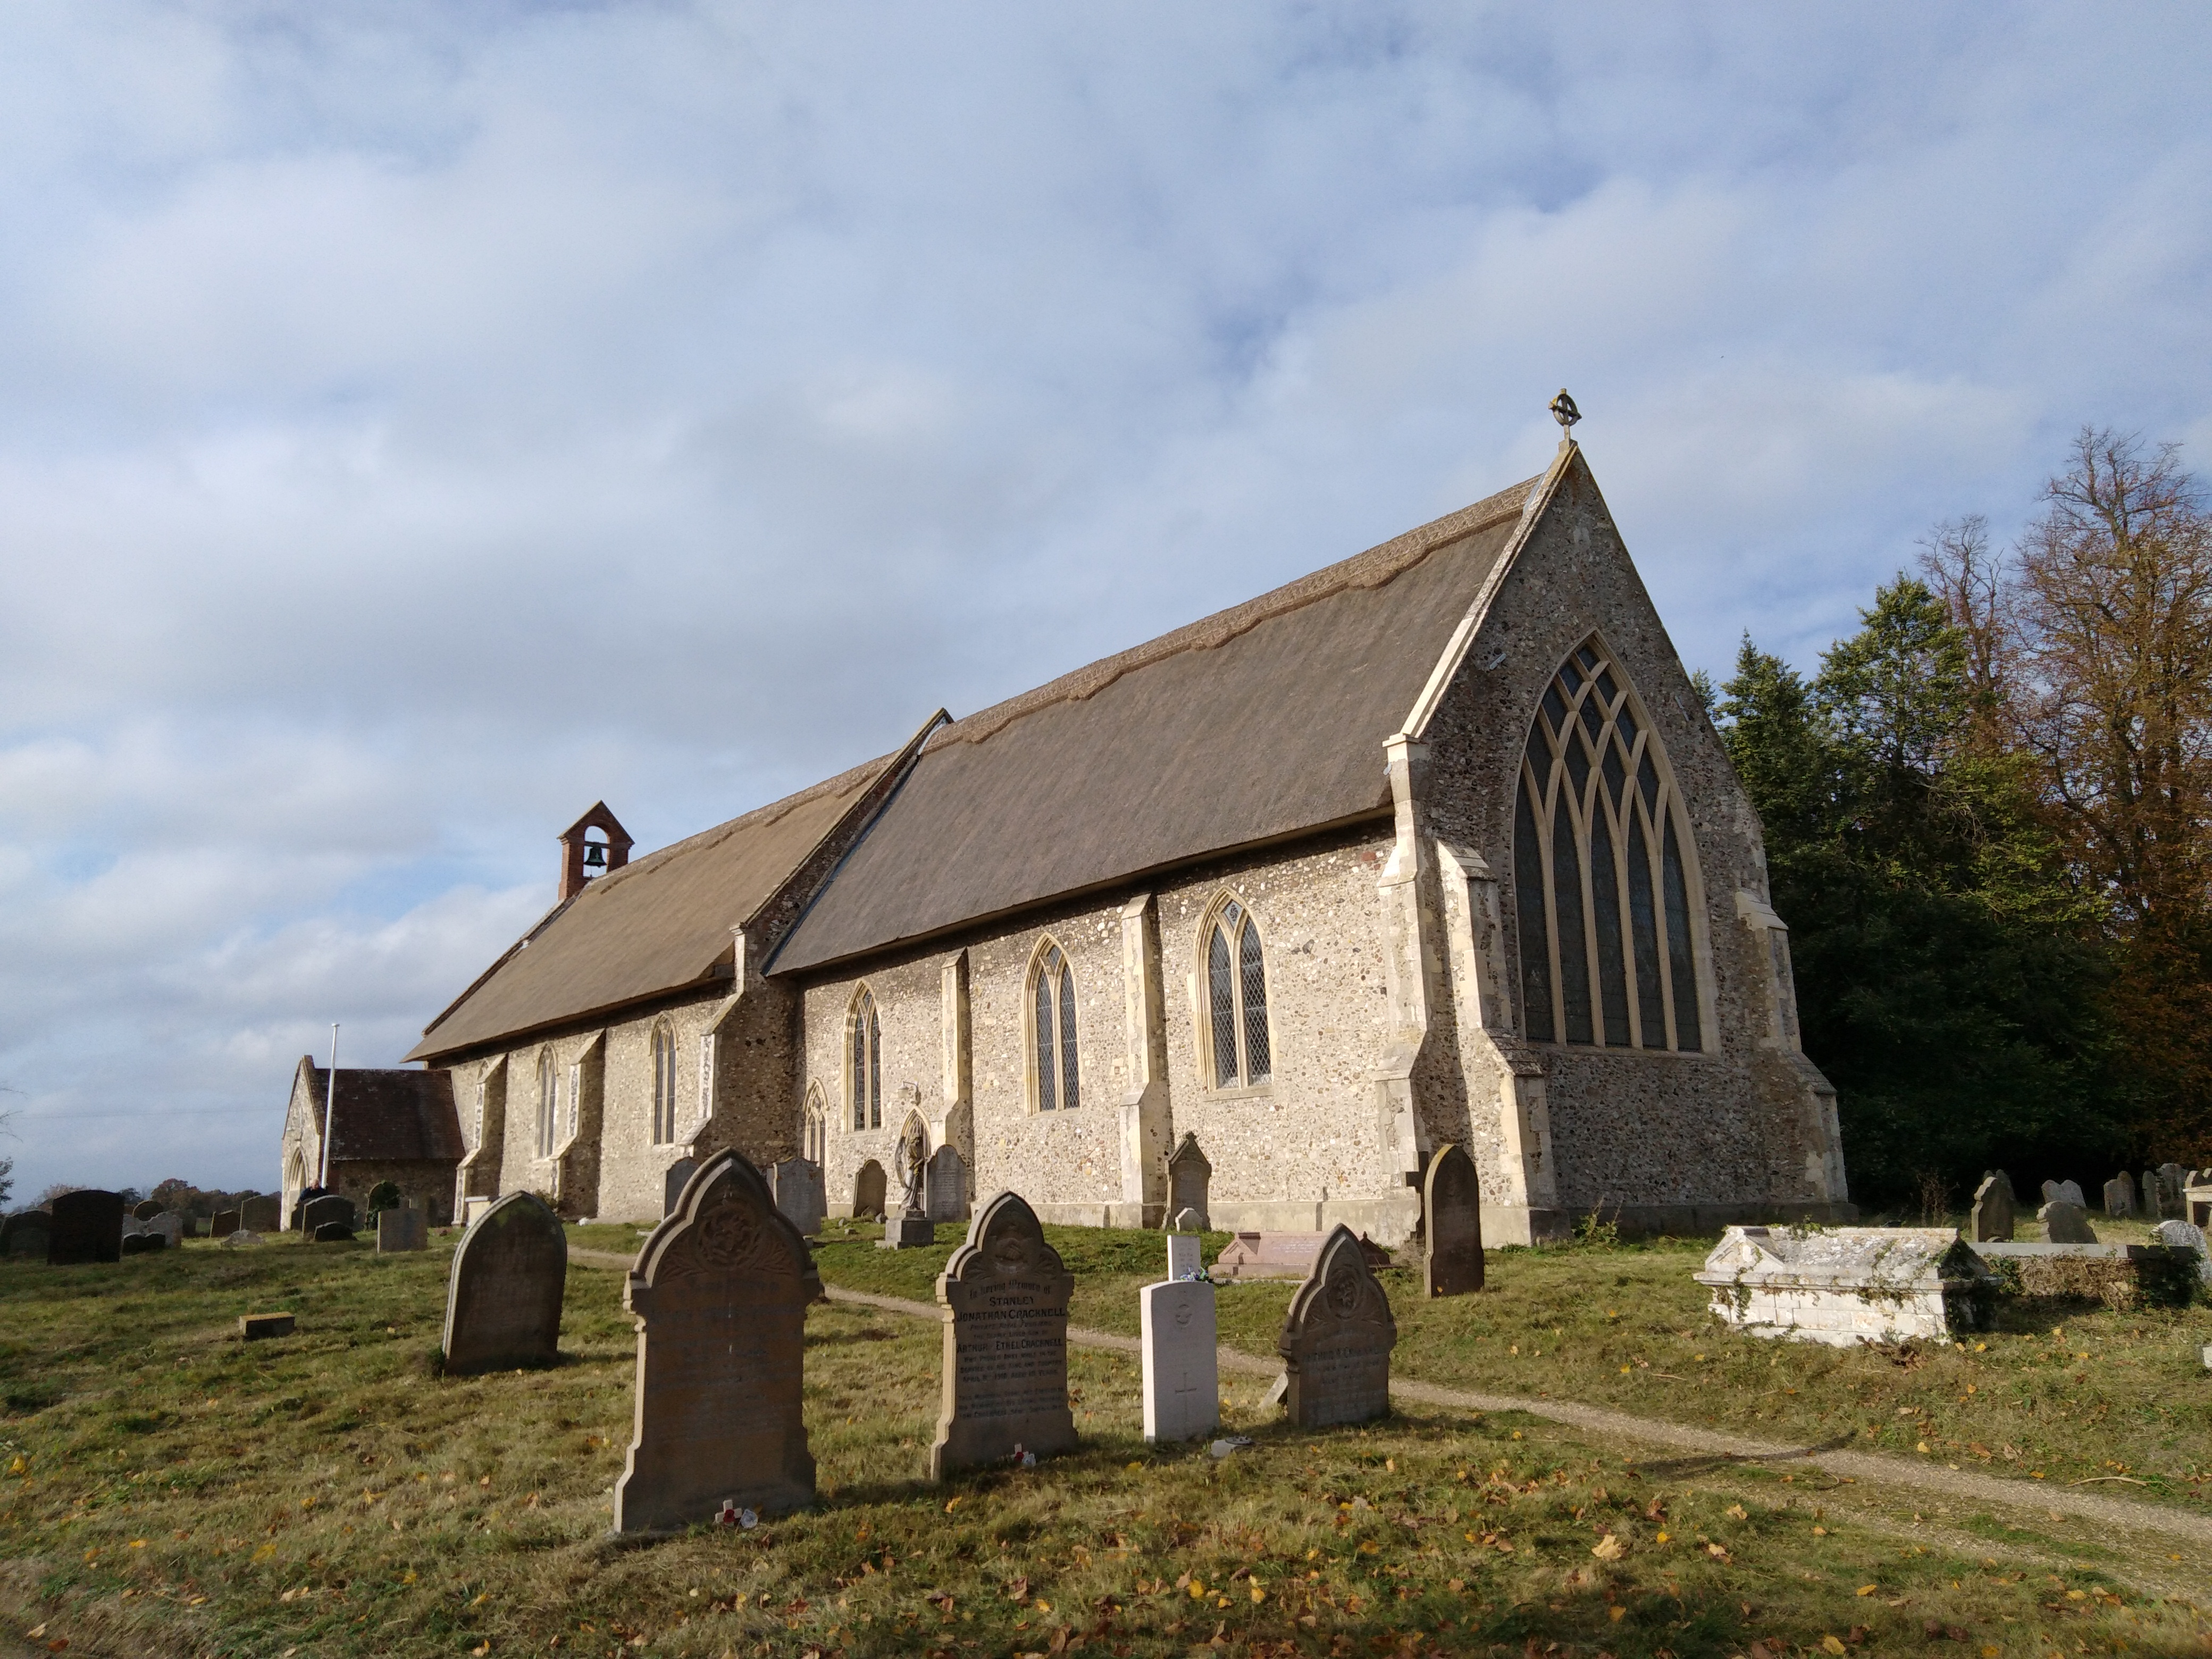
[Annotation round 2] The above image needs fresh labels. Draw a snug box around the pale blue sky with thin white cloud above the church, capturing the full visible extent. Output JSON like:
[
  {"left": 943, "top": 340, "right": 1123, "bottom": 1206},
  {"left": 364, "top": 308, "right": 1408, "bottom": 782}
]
[{"left": 0, "top": 0, "right": 2212, "bottom": 1199}]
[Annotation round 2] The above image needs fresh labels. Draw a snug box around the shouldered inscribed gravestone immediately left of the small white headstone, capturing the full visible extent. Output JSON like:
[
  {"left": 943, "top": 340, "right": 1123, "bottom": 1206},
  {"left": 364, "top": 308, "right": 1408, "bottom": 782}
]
[{"left": 929, "top": 1192, "right": 1075, "bottom": 1480}]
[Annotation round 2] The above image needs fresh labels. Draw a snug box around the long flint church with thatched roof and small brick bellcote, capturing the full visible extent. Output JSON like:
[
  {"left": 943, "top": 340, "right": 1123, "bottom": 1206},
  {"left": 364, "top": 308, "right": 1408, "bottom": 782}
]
[{"left": 389, "top": 438, "right": 1854, "bottom": 1245}]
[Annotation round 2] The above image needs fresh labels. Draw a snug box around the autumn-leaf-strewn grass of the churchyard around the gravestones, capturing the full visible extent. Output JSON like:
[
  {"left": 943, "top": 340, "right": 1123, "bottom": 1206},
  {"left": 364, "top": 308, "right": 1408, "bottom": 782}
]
[{"left": 0, "top": 1223, "right": 2212, "bottom": 1659}]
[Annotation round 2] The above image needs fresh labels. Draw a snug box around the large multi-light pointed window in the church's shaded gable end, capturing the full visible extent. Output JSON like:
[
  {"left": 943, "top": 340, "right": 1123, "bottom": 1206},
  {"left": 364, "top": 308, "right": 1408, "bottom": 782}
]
[{"left": 1513, "top": 635, "right": 1705, "bottom": 1051}]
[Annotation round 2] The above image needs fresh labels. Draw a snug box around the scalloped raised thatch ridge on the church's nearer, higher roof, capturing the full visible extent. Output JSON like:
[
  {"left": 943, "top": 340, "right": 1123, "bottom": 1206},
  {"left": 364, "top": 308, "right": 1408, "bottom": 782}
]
[{"left": 929, "top": 473, "right": 1544, "bottom": 748}]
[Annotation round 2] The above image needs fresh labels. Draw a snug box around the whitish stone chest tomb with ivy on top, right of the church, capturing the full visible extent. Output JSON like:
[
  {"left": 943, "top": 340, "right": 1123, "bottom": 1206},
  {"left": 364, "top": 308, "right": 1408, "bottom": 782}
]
[{"left": 1697, "top": 1228, "right": 1997, "bottom": 1347}]
